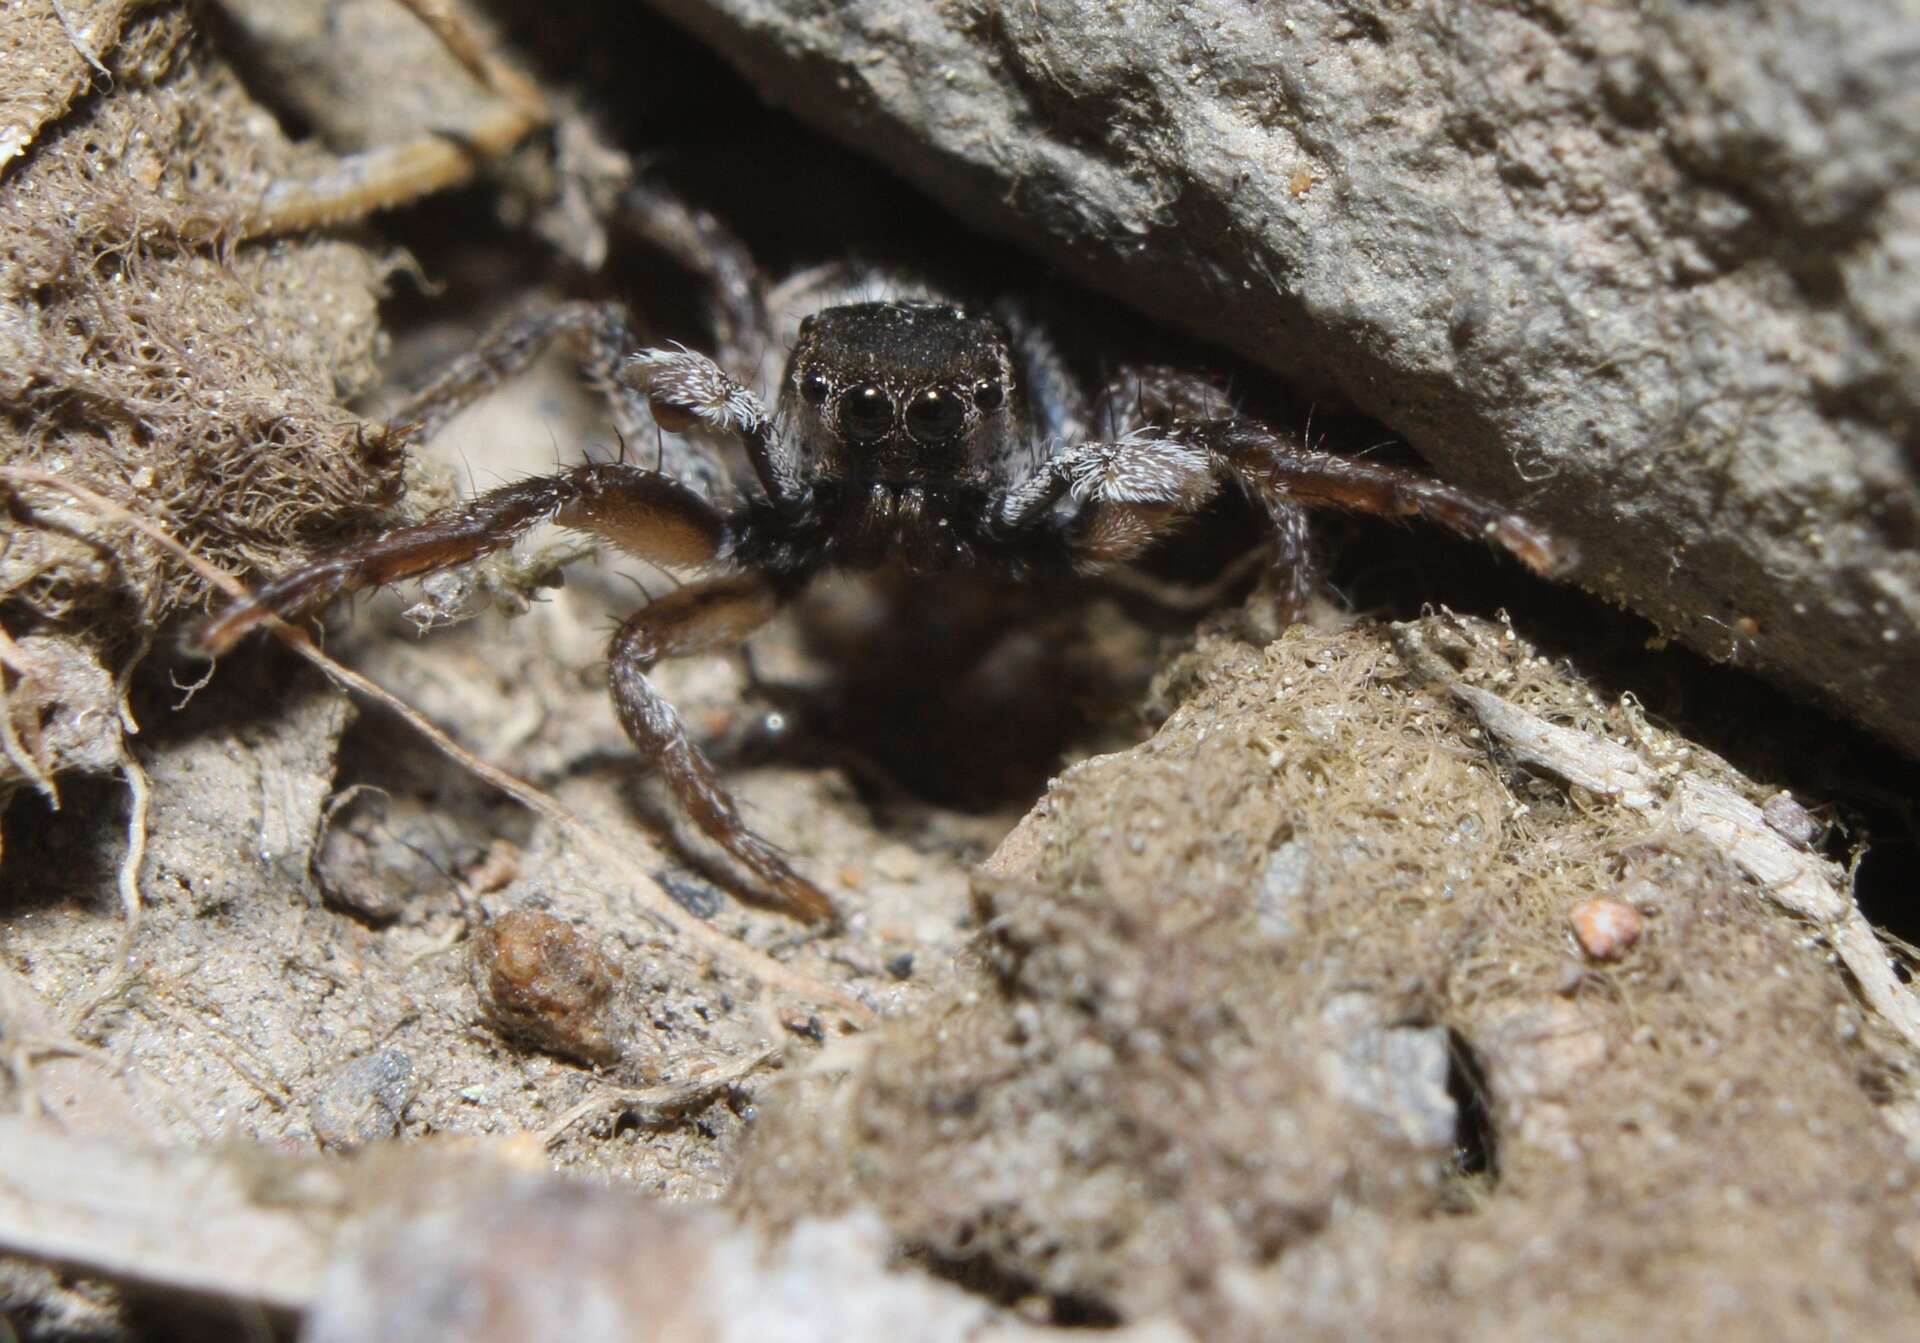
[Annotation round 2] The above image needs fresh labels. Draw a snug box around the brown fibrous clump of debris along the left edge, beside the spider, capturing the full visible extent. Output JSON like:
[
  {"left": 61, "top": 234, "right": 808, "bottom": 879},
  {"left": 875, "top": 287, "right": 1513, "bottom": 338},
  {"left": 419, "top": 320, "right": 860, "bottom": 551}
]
[{"left": 0, "top": 6, "right": 403, "bottom": 810}]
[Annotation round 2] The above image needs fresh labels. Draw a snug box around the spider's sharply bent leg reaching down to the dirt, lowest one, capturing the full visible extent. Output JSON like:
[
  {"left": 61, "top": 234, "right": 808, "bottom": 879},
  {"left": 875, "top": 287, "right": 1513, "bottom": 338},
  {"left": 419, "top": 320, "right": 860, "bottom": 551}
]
[{"left": 607, "top": 573, "right": 835, "bottom": 922}]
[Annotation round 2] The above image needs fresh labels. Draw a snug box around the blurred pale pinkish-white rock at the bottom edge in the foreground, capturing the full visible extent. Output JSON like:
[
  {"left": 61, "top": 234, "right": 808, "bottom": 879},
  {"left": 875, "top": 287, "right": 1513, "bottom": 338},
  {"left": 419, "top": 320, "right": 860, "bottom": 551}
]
[{"left": 300, "top": 1178, "right": 1006, "bottom": 1343}]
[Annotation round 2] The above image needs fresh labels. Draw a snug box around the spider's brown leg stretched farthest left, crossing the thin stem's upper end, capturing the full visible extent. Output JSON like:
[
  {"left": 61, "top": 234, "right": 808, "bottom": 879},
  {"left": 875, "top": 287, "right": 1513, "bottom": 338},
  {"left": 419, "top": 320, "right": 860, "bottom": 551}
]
[{"left": 198, "top": 463, "right": 726, "bottom": 655}]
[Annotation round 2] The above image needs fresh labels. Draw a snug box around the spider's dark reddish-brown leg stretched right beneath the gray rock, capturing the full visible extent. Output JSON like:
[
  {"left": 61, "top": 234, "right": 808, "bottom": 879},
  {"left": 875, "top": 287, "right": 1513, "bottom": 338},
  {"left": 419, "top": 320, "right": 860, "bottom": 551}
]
[{"left": 1192, "top": 419, "right": 1576, "bottom": 576}]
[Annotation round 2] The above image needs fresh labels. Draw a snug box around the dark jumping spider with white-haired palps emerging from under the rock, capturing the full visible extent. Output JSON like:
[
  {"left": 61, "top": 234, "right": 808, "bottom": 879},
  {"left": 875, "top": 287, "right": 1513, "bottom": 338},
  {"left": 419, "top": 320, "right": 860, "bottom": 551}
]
[{"left": 202, "top": 188, "right": 1571, "bottom": 920}]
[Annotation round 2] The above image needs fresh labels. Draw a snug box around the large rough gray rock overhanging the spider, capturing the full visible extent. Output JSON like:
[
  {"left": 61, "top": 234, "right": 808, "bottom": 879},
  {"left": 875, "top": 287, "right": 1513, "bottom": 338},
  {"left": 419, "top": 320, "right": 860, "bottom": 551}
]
[{"left": 655, "top": 0, "right": 1920, "bottom": 751}]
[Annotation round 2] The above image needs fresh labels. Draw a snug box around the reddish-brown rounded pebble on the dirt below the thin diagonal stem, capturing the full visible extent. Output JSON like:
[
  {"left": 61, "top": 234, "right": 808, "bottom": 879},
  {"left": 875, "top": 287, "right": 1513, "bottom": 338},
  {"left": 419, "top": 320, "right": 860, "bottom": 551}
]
[{"left": 474, "top": 909, "right": 620, "bottom": 1064}]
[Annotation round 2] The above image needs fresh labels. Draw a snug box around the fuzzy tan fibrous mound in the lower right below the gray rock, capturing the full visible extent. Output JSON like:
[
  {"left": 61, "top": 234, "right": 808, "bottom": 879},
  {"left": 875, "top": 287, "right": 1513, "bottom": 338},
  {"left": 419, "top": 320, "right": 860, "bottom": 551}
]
[{"left": 737, "top": 617, "right": 1920, "bottom": 1339}]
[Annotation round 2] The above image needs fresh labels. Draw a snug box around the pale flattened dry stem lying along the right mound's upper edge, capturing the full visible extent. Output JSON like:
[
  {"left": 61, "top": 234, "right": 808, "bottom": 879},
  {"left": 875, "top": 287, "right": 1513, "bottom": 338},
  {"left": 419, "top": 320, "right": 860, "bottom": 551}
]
[{"left": 1452, "top": 682, "right": 1920, "bottom": 1049}]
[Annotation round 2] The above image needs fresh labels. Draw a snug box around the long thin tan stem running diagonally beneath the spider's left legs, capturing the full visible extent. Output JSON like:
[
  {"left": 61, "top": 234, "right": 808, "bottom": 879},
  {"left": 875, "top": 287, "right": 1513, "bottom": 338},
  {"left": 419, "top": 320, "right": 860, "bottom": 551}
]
[{"left": 0, "top": 467, "right": 877, "bottom": 1026}]
